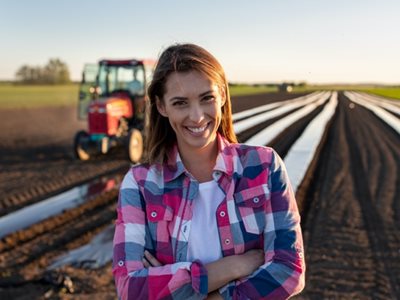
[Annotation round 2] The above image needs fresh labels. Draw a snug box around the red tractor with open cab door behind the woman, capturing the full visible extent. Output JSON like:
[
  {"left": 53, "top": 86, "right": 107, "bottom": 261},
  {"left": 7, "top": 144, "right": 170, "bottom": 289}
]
[{"left": 74, "top": 59, "right": 154, "bottom": 163}]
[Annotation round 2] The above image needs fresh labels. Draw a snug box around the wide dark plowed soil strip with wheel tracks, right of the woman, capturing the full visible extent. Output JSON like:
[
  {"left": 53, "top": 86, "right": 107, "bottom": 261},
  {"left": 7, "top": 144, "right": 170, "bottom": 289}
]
[{"left": 296, "top": 94, "right": 400, "bottom": 299}]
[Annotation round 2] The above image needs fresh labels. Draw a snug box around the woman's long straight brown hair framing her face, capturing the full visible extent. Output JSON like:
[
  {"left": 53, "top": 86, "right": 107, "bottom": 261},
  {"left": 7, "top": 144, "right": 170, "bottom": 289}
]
[{"left": 145, "top": 44, "right": 237, "bottom": 164}]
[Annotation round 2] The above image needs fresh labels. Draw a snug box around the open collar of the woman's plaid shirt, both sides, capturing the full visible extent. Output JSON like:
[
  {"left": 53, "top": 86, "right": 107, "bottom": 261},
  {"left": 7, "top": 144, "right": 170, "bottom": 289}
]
[{"left": 163, "top": 133, "right": 233, "bottom": 182}]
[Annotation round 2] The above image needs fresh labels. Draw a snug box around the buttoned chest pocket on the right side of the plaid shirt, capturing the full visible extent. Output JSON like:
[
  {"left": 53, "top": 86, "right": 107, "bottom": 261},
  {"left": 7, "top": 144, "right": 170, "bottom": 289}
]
[{"left": 233, "top": 184, "right": 271, "bottom": 235}]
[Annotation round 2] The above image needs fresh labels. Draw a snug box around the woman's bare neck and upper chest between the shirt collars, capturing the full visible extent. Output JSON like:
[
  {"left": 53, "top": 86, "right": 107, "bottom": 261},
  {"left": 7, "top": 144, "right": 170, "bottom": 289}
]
[{"left": 179, "top": 141, "right": 218, "bottom": 182}]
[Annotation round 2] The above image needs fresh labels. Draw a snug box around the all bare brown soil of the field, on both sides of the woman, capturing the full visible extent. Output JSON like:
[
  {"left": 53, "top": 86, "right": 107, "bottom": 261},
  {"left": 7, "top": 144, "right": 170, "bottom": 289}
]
[{"left": 0, "top": 94, "right": 400, "bottom": 299}]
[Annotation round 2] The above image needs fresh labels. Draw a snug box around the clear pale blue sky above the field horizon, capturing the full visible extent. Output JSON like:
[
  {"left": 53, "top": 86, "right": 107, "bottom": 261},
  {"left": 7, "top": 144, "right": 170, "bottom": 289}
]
[{"left": 0, "top": 0, "right": 400, "bottom": 84}]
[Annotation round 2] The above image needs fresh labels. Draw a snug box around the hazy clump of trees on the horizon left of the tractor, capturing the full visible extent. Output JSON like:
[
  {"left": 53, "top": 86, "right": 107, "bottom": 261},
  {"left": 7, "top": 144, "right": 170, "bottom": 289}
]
[{"left": 15, "top": 58, "right": 71, "bottom": 84}]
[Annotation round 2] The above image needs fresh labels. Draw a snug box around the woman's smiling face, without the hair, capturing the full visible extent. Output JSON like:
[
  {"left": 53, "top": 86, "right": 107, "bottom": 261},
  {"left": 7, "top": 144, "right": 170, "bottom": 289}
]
[{"left": 157, "top": 71, "right": 225, "bottom": 153}]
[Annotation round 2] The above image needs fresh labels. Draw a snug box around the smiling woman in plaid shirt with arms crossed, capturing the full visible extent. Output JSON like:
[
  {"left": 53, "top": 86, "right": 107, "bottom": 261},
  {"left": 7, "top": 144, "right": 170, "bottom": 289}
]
[{"left": 113, "top": 44, "right": 305, "bottom": 299}]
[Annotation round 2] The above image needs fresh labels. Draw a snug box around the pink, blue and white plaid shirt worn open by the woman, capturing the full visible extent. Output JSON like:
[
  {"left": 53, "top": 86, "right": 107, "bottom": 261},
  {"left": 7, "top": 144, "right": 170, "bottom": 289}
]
[{"left": 113, "top": 136, "right": 305, "bottom": 299}]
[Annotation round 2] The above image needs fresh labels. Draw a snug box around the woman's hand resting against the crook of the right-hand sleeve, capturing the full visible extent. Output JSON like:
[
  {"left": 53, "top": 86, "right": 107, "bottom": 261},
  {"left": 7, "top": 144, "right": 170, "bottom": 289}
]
[{"left": 234, "top": 249, "right": 264, "bottom": 278}]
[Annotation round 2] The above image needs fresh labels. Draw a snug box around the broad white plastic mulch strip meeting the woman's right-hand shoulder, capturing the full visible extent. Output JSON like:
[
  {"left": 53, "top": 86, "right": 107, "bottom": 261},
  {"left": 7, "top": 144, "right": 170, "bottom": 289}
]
[{"left": 284, "top": 92, "right": 338, "bottom": 192}]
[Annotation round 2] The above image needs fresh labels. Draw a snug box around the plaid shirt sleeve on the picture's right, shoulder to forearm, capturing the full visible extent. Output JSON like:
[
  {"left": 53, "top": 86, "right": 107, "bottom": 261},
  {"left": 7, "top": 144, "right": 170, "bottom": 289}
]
[{"left": 219, "top": 151, "right": 305, "bottom": 299}]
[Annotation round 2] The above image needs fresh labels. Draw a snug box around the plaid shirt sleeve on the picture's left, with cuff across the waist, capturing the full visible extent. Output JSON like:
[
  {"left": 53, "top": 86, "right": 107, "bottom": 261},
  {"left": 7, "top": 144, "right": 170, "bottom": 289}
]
[{"left": 113, "top": 170, "right": 208, "bottom": 299}]
